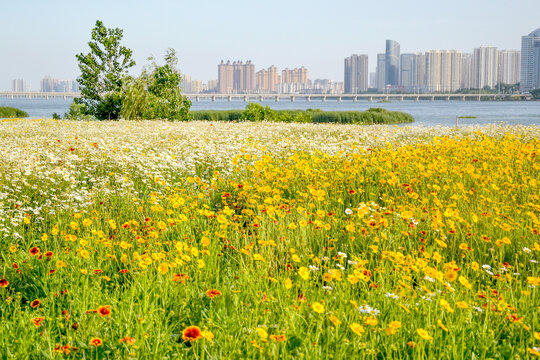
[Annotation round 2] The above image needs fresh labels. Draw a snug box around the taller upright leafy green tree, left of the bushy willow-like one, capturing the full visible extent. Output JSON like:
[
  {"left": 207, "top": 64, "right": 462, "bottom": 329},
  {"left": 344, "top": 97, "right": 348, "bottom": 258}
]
[{"left": 75, "top": 20, "right": 135, "bottom": 120}]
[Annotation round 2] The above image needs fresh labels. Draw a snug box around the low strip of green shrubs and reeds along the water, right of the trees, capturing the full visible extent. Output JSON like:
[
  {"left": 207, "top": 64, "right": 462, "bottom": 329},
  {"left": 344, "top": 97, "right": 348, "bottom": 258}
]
[{"left": 191, "top": 103, "right": 414, "bottom": 125}]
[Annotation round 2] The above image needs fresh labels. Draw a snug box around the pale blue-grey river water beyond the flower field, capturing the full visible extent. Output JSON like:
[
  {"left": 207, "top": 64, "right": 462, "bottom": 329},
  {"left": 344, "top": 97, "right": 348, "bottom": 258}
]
[{"left": 0, "top": 98, "right": 540, "bottom": 126}]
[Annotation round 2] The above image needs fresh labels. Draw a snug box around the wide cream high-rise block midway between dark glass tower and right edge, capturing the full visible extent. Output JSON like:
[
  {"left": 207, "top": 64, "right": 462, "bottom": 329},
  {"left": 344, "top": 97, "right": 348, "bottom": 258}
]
[{"left": 426, "top": 50, "right": 461, "bottom": 92}]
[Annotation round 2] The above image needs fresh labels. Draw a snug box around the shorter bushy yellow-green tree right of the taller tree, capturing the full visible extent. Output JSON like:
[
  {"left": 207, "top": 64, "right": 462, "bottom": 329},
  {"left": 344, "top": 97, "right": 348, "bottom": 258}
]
[{"left": 122, "top": 49, "right": 191, "bottom": 120}]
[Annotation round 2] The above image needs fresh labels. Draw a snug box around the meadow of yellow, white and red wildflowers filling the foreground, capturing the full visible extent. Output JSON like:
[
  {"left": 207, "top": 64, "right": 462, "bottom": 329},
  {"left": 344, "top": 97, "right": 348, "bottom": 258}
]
[{"left": 0, "top": 119, "right": 540, "bottom": 359}]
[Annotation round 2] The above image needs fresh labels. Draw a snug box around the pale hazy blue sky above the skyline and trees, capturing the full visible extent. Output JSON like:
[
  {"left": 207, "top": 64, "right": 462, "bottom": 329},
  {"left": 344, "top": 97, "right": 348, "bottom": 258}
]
[{"left": 0, "top": 0, "right": 540, "bottom": 90}]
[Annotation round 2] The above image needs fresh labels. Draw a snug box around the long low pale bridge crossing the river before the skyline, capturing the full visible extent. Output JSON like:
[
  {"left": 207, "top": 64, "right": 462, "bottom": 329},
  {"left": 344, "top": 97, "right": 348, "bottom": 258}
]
[{"left": 0, "top": 91, "right": 530, "bottom": 102}]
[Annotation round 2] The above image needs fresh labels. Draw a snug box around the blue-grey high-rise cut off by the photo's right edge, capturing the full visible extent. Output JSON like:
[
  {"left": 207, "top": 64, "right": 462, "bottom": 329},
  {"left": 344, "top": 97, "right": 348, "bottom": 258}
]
[{"left": 520, "top": 28, "right": 540, "bottom": 91}]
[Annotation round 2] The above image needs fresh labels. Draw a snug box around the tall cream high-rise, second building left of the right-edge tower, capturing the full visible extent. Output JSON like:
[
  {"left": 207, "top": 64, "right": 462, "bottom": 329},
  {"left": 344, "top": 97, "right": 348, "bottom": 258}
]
[{"left": 474, "top": 46, "right": 499, "bottom": 89}]
